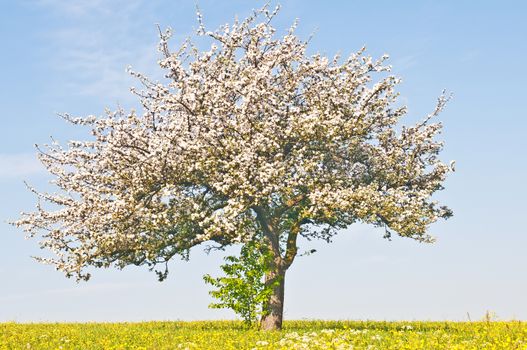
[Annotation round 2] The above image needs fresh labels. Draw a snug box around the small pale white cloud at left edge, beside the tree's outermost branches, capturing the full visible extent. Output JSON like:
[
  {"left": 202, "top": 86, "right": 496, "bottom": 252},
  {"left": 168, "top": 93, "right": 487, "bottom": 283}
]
[{"left": 0, "top": 153, "right": 45, "bottom": 179}]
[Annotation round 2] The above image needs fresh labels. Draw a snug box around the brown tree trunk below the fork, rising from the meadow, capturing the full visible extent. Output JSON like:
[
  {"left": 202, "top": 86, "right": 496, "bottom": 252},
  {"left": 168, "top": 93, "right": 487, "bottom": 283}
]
[{"left": 260, "top": 266, "right": 285, "bottom": 331}]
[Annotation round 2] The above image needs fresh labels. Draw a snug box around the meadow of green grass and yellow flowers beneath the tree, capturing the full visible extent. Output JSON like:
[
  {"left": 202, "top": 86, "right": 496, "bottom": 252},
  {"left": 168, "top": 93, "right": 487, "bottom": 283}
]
[{"left": 0, "top": 321, "right": 527, "bottom": 350}]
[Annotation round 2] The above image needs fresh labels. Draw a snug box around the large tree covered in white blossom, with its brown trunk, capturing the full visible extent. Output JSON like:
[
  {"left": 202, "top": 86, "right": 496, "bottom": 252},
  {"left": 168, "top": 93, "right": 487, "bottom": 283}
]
[{"left": 15, "top": 7, "right": 452, "bottom": 329}]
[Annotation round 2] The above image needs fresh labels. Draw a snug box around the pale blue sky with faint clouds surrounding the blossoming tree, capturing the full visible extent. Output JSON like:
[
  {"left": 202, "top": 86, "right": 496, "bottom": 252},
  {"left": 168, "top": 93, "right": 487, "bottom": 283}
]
[{"left": 0, "top": 0, "right": 527, "bottom": 322}]
